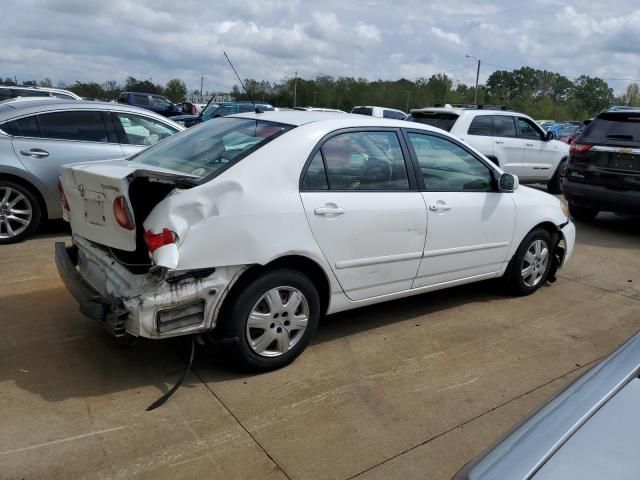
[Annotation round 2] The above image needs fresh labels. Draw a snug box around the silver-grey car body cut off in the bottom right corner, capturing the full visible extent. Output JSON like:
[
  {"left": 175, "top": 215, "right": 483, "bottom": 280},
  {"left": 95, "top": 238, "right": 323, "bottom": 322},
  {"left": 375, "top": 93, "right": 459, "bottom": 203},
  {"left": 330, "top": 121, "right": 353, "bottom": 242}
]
[{"left": 454, "top": 334, "right": 640, "bottom": 480}]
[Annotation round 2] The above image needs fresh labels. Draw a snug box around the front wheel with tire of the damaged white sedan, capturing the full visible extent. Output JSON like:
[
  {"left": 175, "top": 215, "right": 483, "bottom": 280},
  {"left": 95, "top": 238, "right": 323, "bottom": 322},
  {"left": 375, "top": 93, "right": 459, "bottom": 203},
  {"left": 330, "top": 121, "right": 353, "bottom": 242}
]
[{"left": 504, "top": 228, "right": 553, "bottom": 296}]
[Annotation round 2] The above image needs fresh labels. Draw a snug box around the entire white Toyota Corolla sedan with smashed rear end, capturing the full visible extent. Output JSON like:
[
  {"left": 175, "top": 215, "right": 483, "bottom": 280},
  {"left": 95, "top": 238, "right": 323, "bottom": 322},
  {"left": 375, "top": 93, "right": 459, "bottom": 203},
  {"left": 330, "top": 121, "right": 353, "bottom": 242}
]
[{"left": 56, "top": 111, "right": 575, "bottom": 370}]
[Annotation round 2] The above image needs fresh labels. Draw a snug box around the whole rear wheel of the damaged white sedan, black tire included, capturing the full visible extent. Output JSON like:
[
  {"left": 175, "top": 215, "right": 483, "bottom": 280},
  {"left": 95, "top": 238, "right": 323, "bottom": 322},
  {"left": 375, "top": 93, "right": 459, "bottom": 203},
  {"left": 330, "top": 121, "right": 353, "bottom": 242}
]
[{"left": 214, "top": 269, "right": 320, "bottom": 372}]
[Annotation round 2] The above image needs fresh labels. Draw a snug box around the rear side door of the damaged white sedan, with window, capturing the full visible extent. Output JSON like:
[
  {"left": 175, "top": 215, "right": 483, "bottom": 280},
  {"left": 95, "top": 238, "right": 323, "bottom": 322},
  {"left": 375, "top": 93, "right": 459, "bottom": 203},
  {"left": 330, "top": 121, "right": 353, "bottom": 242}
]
[{"left": 300, "top": 129, "right": 427, "bottom": 300}]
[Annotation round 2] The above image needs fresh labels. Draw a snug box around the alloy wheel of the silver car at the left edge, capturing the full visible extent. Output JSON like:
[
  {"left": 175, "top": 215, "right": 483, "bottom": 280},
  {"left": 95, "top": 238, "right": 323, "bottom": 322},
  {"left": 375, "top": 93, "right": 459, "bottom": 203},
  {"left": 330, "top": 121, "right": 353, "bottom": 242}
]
[{"left": 0, "top": 180, "right": 40, "bottom": 245}]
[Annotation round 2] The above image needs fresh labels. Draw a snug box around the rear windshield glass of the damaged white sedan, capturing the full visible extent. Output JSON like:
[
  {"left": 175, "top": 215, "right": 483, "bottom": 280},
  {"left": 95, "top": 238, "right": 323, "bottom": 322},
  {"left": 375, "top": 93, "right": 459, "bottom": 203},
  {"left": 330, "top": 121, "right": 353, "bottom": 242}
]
[{"left": 130, "top": 118, "right": 293, "bottom": 178}]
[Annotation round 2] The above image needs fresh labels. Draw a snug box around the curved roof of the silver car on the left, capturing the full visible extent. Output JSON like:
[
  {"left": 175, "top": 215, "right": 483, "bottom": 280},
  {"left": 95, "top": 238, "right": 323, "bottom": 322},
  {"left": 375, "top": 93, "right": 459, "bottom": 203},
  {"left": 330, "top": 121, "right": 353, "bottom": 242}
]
[{"left": 0, "top": 97, "right": 184, "bottom": 130}]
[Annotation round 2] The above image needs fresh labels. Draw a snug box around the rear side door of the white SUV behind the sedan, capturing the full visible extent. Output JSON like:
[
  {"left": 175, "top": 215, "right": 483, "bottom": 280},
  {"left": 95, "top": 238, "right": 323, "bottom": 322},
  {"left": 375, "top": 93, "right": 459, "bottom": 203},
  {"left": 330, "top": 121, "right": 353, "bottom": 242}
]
[{"left": 493, "top": 115, "right": 530, "bottom": 177}]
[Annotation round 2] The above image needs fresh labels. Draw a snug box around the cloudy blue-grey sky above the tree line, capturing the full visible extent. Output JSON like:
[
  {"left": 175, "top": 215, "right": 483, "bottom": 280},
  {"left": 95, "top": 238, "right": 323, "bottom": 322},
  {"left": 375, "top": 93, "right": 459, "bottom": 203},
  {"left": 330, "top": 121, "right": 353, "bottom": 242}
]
[{"left": 0, "top": 0, "right": 640, "bottom": 92}]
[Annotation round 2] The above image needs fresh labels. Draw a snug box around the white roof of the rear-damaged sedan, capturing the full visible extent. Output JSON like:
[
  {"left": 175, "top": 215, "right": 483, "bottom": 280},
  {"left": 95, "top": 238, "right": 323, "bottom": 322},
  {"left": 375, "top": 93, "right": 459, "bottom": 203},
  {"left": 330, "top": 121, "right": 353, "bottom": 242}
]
[{"left": 230, "top": 110, "right": 442, "bottom": 133}]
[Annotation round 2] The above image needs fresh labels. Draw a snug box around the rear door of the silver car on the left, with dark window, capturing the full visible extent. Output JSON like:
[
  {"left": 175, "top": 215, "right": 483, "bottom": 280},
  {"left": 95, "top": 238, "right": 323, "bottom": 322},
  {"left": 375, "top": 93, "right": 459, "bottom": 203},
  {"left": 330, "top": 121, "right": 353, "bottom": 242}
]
[{"left": 10, "top": 110, "right": 124, "bottom": 211}]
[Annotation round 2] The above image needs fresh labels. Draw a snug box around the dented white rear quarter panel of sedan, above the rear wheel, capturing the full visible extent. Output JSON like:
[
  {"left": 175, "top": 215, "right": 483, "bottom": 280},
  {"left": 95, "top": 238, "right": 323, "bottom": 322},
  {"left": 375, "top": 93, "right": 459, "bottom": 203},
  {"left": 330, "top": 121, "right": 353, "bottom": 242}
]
[{"left": 144, "top": 122, "right": 339, "bottom": 291}]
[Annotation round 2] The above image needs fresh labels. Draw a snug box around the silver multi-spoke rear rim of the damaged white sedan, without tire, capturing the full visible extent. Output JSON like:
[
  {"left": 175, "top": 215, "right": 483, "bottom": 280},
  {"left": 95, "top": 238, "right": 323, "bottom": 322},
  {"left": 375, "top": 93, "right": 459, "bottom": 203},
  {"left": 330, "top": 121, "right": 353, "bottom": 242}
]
[{"left": 246, "top": 287, "right": 309, "bottom": 357}]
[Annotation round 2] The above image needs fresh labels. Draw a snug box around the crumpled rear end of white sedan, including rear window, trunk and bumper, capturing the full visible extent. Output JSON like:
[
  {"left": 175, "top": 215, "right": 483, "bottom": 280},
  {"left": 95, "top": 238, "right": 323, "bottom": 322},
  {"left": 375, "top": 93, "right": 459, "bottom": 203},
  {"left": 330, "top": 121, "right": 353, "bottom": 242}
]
[{"left": 55, "top": 119, "right": 286, "bottom": 338}]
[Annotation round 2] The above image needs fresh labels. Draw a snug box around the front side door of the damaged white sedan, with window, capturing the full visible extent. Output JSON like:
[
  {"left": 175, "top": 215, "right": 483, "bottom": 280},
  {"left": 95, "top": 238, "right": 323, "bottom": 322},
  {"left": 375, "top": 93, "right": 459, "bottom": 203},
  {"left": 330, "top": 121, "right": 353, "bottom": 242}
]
[{"left": 406, "top": 131, "right": 516, "bottom": 288}]
